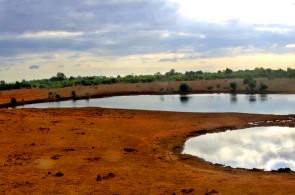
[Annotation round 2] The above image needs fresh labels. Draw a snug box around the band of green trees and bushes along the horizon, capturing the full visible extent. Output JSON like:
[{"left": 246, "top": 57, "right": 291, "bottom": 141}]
[{"left": 0, "top": 67, "right": 295, "bottom": 90}]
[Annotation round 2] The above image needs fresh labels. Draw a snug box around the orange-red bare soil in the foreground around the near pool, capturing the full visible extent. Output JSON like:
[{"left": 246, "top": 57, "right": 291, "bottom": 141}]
[{"left": 0, "top": 108, "right": 295, "bottom": 194}]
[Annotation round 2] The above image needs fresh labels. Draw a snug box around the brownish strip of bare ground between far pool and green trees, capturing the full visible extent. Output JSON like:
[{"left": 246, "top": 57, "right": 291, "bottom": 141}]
[{"left": 0, "top": 78, "right": 295, "bottom": 105}]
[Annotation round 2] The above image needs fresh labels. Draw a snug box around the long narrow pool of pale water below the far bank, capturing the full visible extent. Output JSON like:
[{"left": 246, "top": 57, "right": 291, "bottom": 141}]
[{"left": 21, "top": 94, "right": 295, "bottom": 115}]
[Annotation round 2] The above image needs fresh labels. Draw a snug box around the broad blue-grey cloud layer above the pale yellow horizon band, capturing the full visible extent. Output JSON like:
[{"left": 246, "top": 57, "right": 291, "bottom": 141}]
[{"left": 0, "top": 0, "right": 295, "bottom": 68}]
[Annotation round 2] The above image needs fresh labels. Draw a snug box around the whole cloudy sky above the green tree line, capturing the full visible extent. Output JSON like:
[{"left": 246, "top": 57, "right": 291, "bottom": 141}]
[{"left": 0, "top": 0, "right": 295, "bottom": 82}]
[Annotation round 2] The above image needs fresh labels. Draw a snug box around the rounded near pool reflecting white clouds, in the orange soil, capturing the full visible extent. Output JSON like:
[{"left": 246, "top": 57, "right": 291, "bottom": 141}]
[{"left": 183, "top": 127, "right": 295, "bottom": 171}]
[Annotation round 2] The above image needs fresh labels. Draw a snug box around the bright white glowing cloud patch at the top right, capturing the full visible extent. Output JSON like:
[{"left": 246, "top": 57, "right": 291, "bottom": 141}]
[{"left": 172, "top": 0, "right": 295, "bottom": 25}]
